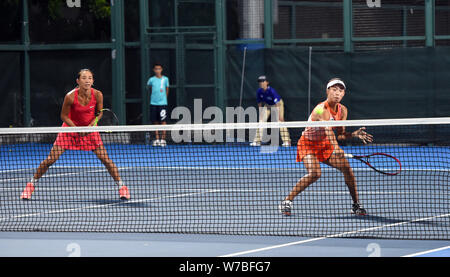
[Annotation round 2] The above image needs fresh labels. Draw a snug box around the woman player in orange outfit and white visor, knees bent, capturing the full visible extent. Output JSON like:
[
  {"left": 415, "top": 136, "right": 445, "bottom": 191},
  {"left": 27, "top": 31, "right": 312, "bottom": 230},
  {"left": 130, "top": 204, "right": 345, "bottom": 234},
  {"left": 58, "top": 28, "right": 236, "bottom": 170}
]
[{"left": 280, "top": 78, "right": 372, "bottom": 216}]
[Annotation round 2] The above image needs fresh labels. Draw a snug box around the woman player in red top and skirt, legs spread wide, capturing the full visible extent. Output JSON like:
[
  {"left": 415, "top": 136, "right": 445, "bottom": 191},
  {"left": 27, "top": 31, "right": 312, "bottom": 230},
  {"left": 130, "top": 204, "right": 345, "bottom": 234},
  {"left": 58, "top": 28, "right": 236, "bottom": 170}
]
[{"left": 20, "top": 69, "right": 130, "bottom": 200}]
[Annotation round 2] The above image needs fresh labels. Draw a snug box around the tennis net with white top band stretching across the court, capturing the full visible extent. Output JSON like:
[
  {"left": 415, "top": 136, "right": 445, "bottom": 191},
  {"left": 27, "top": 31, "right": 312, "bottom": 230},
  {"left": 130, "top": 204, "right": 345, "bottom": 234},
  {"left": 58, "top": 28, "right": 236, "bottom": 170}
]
[{"left": 0, "top": 118, "right": 450, "bottom": 239}]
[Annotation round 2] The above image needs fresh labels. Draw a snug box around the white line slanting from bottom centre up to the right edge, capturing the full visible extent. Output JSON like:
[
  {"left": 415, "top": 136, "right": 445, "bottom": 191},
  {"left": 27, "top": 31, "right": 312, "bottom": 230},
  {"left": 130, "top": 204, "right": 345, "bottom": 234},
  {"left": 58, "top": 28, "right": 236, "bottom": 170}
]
[{"left": 219, "top": 213, "right": 450, "bottom": 257}]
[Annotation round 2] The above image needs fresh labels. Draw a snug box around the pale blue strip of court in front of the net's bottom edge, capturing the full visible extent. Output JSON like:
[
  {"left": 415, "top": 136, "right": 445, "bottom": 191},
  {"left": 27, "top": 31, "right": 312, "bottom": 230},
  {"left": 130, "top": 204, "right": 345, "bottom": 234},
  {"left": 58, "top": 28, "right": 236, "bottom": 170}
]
[{"left": 0, "top": 232, "right": 450, "bottom": 257}]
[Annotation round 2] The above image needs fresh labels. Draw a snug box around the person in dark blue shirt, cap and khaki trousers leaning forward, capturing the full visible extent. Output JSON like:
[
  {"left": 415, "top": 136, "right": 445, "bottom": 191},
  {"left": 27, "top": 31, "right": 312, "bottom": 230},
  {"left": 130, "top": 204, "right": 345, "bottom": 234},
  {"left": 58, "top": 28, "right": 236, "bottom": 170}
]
[{"left": 250, "top": 76, "right": 291, "bottom": 147}]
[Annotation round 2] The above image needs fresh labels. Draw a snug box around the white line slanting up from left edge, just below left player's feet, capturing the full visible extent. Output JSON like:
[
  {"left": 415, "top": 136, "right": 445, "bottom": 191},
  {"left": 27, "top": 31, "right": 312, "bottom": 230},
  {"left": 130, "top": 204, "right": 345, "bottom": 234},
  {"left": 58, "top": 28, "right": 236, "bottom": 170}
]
[{"left": 0, "top": 190, "right": 219, "bottom": 221}]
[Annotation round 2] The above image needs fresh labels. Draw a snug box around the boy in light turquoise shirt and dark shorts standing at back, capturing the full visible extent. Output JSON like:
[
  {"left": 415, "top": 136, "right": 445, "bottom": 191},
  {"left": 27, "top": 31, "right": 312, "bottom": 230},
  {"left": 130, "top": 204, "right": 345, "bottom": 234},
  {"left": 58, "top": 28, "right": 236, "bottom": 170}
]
[{"left": 147, "top": 63, "right": 169, "bottom": 146}]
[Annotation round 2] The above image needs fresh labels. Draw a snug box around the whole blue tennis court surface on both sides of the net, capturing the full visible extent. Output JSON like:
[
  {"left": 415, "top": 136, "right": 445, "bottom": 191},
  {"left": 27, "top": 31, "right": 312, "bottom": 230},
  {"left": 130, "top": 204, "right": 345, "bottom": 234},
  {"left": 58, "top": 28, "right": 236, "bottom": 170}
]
[{"left": 0, "top": 139, "right": 450, "bottom": 256}]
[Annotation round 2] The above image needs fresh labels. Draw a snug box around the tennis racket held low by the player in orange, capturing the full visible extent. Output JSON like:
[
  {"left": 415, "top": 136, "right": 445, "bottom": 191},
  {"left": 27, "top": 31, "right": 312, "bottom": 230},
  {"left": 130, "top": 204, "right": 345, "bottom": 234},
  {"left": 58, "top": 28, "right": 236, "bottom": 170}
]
[{"left": 344, "top": 153, "right": 402, "bottom": 176}]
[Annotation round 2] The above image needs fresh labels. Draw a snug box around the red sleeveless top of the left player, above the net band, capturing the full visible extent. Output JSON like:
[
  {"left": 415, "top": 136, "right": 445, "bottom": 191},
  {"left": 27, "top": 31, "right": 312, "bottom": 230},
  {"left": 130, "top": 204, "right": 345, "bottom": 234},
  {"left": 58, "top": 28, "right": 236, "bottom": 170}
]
[{"left": 63, "top": 88, "right": 97, "bottom": 127}]
